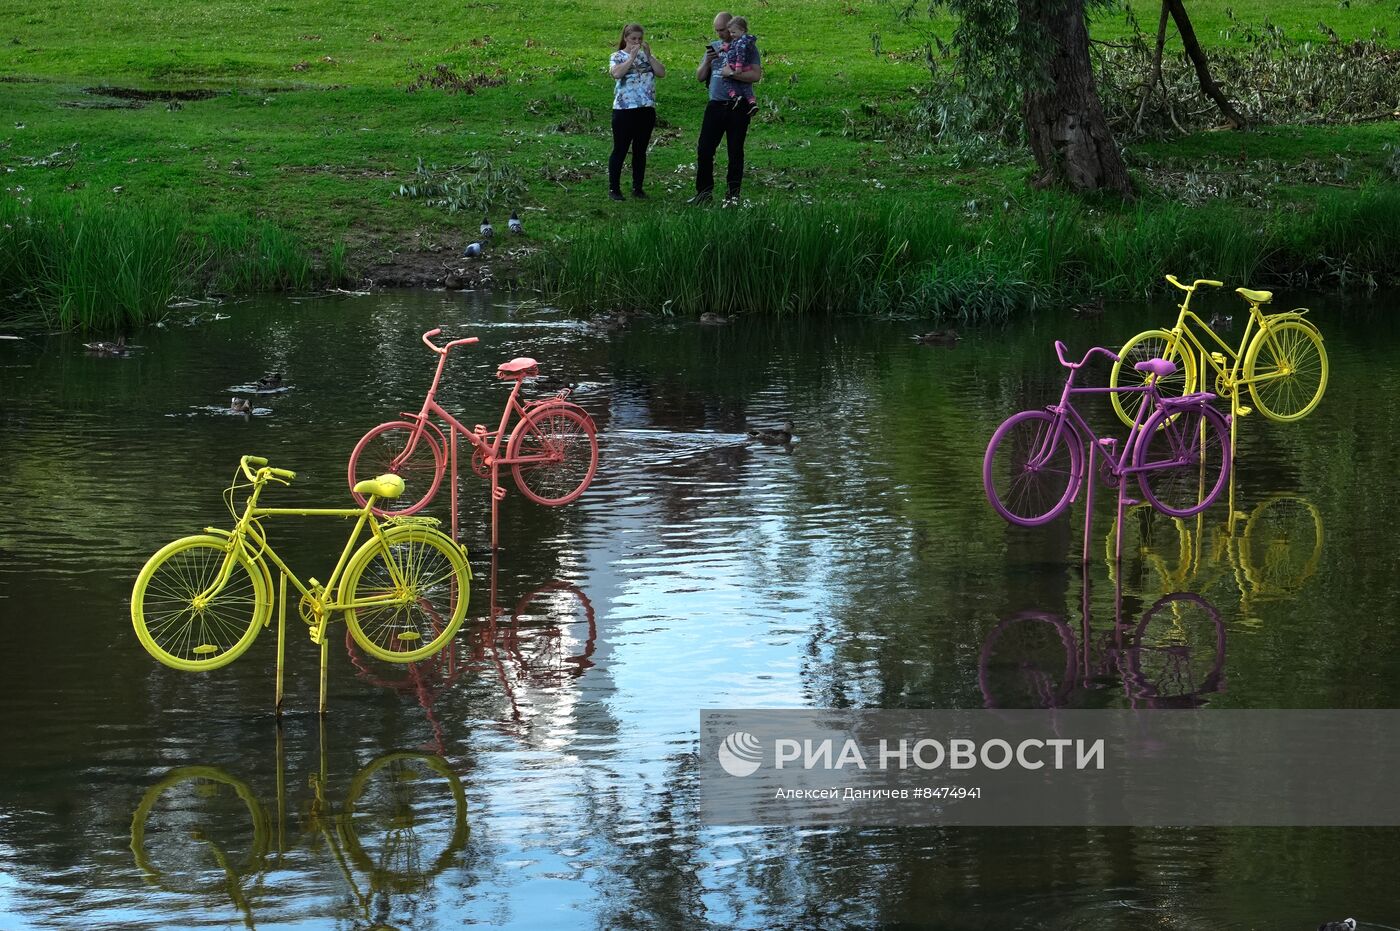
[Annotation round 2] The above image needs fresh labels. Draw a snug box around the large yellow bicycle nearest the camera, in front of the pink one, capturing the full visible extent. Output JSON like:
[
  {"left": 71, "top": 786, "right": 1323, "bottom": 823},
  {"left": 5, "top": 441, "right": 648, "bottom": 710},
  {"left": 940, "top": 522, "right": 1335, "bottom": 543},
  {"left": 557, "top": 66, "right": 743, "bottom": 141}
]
[{"left": 132, "top": 456, "right": 472, "bottom": 672}]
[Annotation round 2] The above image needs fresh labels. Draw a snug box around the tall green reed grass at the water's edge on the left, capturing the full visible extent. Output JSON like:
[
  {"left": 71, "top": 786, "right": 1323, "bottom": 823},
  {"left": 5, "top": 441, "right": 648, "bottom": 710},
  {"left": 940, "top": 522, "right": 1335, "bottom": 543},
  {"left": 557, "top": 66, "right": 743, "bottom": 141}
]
[{"left": 0, "top": 196, "right": 350, "bottom": 333}]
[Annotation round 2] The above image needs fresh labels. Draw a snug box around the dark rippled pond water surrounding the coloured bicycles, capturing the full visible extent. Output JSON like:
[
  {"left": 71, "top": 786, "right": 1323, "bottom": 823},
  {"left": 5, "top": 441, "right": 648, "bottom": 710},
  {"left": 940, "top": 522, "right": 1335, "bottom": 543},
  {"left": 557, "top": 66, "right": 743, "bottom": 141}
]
[{"left": 0, "top": 293, "right": 1400, "bottom": 928}]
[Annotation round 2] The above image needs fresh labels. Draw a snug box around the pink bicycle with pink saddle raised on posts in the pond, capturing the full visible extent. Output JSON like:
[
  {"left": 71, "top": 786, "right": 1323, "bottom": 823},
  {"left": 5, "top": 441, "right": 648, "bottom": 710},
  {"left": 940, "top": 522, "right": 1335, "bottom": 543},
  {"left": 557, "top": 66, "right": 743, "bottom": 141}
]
[{"left": 349, "top": 329, "right": 598, "bottom": 537}]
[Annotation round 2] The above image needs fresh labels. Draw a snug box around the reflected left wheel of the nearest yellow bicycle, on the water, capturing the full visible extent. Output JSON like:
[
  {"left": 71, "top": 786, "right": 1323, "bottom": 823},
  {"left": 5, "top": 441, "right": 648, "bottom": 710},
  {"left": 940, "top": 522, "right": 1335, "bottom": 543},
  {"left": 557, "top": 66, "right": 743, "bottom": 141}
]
[{"left": 132, "top": 766, "right": 269, "bottom": 902}]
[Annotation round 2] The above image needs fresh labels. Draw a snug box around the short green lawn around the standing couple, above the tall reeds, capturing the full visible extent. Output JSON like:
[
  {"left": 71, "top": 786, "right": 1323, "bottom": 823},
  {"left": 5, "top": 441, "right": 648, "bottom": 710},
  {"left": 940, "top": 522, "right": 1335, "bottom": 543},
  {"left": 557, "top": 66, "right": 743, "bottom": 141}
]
[{"left": 0, "top": 0, "right": 1400, "bottom": 326}]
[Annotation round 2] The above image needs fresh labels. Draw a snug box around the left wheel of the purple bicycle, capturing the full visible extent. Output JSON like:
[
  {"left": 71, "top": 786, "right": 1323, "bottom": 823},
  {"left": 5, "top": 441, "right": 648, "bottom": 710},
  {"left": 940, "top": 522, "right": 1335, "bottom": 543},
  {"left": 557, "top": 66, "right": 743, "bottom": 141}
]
[{"left": 981, "top": 410, "right": 1084, "bottom": 526}]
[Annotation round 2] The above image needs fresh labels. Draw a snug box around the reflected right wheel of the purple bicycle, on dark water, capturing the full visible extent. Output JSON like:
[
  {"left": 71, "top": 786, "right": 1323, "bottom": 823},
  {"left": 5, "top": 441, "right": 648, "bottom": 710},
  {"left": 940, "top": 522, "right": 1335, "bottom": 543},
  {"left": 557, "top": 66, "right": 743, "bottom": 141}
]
[{"left": 1126, "top": 592, "right": 1225, "bottom": 707}]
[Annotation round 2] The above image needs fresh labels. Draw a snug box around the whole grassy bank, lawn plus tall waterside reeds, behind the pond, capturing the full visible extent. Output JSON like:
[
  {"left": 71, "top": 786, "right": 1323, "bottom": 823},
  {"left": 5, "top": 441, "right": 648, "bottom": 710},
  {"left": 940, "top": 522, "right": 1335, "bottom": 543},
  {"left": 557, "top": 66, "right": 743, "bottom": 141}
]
[{"left": 0, "top": 0, "right": 1400, "bottom": 322}]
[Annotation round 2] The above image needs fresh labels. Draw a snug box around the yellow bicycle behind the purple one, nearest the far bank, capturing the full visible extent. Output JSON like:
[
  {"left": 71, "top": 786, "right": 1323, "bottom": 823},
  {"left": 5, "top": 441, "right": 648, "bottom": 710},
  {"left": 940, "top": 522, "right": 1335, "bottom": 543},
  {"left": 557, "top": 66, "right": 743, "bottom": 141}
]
[{"left": 1109, "top": 274, "right": 1327, "bottom": 426}]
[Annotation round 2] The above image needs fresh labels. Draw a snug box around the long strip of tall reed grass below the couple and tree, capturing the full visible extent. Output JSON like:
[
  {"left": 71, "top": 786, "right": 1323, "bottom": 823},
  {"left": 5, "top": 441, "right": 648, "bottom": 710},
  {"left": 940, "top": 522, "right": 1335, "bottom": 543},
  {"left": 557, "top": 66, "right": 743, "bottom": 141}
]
[{"left": 535, "top": 188, "right": 1400, "bottom": 321}]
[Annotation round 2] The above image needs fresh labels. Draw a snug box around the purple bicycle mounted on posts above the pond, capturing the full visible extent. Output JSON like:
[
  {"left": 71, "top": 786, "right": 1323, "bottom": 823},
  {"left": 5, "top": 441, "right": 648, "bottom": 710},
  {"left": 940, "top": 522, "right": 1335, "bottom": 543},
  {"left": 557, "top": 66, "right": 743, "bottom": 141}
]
[{"left": 981, "top": 340, "right": 1231, "bottom": 526}]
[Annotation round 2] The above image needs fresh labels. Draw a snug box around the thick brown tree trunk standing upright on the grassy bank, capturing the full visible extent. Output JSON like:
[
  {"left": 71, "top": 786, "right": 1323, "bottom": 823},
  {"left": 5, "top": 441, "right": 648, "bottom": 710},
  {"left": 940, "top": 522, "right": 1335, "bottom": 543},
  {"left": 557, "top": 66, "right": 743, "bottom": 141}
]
[{"left": 1016, "top": 0, "right": 1133, "bottom": 196}]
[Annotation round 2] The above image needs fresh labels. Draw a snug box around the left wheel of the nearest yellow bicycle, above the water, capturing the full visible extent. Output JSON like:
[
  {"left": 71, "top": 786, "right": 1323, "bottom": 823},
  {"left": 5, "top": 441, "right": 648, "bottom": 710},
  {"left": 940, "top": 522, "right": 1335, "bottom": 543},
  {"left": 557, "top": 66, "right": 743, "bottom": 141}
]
[{"left": 132, "top": 535, "right": 272, "bottom": 672}]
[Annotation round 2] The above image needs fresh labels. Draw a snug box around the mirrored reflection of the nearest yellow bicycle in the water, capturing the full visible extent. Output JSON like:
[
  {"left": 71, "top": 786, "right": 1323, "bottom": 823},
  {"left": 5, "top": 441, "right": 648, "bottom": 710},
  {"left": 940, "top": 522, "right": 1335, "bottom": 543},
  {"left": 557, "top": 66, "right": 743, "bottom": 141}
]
[{"left": 132, "top": 721, "right": 470, "bottom": 928}]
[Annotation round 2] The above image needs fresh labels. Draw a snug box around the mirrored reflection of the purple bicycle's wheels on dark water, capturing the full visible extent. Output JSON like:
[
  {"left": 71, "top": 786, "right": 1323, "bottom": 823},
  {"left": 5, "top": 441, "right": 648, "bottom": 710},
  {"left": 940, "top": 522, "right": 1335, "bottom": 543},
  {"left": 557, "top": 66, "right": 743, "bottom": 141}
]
[{"left": 977, "top": 582, "right": 1225, "bottom": 708}]
